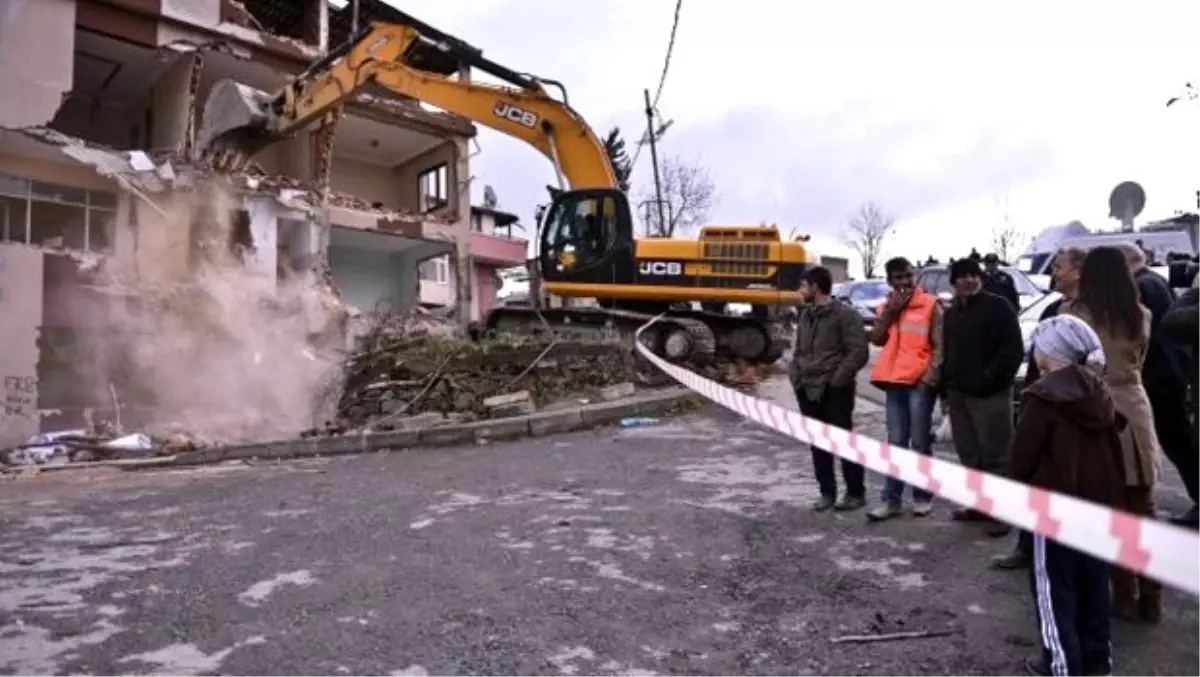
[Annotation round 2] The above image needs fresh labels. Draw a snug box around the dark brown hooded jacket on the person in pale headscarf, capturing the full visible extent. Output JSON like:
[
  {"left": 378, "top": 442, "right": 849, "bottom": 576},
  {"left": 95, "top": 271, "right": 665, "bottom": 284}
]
[{"left": 1013, "top": 365, "right": 1126, "bottom": 507}]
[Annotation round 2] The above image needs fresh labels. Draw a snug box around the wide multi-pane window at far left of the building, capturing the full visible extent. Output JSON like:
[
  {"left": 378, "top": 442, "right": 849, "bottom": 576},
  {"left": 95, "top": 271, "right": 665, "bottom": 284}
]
[{"left": 0, "top": 174, "right": 116, "bottom": 252}]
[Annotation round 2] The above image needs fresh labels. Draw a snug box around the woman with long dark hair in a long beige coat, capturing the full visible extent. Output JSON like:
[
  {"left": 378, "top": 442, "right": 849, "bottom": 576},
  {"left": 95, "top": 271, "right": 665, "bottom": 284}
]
[{"left": 1058, "top": 247, "right": 1163, "bottom": 623}]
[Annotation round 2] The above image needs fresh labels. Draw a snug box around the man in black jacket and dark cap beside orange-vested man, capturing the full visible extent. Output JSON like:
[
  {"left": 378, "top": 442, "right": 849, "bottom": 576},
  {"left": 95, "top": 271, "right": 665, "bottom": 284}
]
[{"left": 943, "top": 258, "right": 1025, "bottom": 538}]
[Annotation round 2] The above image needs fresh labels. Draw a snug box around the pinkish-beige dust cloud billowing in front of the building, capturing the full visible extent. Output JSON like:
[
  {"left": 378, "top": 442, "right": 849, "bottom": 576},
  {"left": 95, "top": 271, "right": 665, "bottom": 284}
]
[{"left": 91, "top": 179, "right": 348, "bottom": 443}]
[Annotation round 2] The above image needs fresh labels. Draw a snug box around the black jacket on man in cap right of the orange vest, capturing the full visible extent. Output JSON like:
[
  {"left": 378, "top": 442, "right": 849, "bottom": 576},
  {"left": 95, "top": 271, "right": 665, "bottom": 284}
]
[{"left": 942, "top": 292, "right": 1025, "bottom": 397}]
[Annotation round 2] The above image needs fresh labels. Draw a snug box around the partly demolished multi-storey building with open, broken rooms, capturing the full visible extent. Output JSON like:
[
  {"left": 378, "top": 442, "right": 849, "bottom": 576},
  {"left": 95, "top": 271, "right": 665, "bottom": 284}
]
[{"left": 0, "top": 0, "right": 526, "bottom": 447}]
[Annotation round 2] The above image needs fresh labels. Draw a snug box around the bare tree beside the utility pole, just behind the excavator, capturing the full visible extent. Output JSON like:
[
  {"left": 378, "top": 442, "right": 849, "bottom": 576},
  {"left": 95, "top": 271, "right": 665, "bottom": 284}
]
[{"left": 641, "top": 156, "right": 716, "bottom": 238}]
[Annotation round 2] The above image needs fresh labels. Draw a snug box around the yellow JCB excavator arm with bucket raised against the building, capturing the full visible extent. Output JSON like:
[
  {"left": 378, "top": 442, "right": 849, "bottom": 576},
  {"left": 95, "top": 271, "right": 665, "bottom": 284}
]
[{"left": 198, "top": 20, "right": 617, "bottom": 190}]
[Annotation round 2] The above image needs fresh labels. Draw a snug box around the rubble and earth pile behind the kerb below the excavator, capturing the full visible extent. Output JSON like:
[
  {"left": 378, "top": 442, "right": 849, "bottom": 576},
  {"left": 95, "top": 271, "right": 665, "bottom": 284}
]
[{"left": 308, "top": 316, "right": 636, "bottom": 435}]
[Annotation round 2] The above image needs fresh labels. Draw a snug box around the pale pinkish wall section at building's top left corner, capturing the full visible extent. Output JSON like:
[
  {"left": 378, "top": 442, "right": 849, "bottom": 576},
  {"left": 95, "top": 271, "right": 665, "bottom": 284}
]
[{"left": 0, "top": 0, "right": 76, "bottom": 127}]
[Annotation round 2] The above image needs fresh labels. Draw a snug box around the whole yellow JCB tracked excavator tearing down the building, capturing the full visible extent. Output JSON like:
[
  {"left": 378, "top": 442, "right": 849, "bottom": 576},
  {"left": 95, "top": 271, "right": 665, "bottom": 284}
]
[{"left": 198, "top": 7, "right": 809, "bottom": 363}]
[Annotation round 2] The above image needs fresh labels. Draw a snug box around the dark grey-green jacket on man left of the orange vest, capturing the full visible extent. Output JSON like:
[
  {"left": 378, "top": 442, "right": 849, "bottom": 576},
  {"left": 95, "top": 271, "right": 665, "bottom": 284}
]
[{"left": 791, "top": 299, "right": 870, "bottom": 388}]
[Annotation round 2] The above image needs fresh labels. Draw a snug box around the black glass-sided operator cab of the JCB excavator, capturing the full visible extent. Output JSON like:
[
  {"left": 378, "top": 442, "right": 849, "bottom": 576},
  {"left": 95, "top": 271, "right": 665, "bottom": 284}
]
[{"left": 538, "top": 188, "right": 634, "bottom": 284}]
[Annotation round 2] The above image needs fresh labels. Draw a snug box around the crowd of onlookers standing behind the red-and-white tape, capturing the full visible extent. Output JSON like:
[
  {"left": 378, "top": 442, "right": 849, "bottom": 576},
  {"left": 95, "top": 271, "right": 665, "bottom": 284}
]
[{"left": 791, "top": 244, "right": 1200, "bottom": 676}]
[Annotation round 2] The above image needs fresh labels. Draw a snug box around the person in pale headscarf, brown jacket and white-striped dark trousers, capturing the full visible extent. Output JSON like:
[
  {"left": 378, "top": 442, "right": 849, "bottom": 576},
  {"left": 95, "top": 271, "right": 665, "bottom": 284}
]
[{"left": 1013, "top": 314, "right": 1124, "bottom": 677}]
